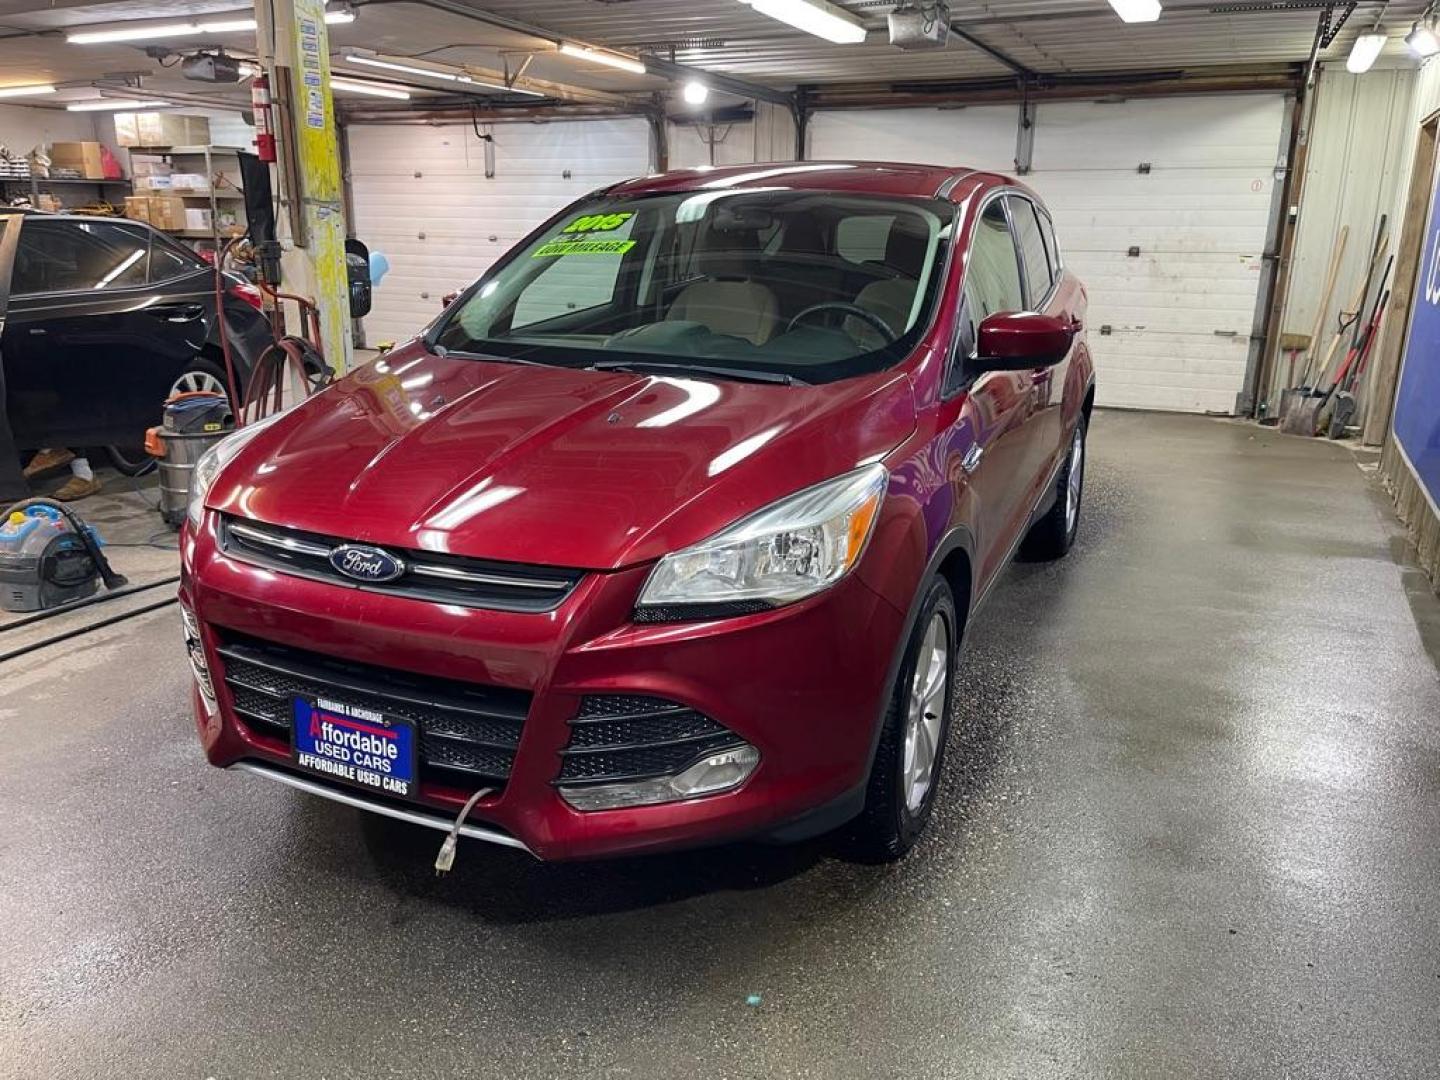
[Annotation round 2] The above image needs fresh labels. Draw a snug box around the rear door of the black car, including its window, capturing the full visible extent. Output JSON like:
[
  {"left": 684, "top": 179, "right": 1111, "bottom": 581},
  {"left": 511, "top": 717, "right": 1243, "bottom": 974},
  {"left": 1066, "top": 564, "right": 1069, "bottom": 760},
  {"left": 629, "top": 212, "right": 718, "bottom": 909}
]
[{"left": 4, "top": 217, "right": 213, "bottom": 446}]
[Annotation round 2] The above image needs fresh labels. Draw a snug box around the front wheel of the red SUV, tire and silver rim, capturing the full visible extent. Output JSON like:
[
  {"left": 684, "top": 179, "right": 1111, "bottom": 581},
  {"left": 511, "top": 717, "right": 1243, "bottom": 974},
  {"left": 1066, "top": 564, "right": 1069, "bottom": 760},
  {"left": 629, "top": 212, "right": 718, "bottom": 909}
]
[{"left": 851, "top": 576, "right": 960, "bottom": 863}]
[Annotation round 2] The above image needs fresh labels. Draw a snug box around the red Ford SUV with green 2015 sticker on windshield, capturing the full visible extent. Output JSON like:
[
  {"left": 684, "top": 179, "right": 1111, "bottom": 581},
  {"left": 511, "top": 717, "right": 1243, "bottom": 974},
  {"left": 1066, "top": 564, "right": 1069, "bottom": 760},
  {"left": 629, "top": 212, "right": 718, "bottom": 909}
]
[{"left": 180, "top": 163, "right": 1093, "bottom": 858}]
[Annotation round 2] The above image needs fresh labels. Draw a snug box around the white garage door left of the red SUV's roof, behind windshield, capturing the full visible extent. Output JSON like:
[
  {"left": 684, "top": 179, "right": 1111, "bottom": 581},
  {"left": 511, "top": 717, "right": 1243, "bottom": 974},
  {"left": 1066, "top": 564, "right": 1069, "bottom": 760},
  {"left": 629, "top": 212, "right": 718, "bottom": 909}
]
[{"left": 348, "top": 118, "right": 651, "bottom": 344}]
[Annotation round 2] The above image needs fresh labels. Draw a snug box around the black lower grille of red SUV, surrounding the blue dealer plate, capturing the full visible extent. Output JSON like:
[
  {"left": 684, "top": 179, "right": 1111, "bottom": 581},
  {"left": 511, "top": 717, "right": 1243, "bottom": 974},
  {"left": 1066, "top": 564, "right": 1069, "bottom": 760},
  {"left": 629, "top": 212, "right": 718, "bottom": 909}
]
[{"left": 210, "top": 631, "right": 530, "bottom": 788}]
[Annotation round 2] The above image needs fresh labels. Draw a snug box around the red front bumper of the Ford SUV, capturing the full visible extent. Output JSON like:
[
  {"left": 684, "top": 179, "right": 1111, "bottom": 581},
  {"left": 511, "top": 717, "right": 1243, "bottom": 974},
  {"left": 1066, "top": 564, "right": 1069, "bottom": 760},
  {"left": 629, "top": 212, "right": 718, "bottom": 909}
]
[{"left": 181, "top": 514, "right": 903, "bottom": 860}]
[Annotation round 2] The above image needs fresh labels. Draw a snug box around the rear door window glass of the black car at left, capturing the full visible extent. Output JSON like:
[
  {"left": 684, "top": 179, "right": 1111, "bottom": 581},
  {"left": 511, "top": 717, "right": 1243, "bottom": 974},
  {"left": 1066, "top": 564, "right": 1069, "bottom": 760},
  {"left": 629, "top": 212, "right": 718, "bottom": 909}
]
[{"left": 10, "top": 220, "right": 150, "bottom": 295}]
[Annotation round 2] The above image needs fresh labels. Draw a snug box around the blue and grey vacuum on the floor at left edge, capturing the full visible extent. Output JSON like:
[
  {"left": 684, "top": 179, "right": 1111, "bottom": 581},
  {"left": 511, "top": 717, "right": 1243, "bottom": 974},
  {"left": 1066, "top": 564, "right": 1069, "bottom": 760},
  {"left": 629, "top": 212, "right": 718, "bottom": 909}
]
[{"left": 0, "top": 498, "right": 127, "bottom": 612}]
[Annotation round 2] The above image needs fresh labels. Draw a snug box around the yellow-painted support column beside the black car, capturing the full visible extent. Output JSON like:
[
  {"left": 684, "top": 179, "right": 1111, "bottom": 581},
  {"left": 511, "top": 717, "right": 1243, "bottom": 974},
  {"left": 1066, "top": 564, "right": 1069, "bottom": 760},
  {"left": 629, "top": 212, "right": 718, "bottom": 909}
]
[{"left": 255, "top": 0, "right": 351, "bottom": 374}]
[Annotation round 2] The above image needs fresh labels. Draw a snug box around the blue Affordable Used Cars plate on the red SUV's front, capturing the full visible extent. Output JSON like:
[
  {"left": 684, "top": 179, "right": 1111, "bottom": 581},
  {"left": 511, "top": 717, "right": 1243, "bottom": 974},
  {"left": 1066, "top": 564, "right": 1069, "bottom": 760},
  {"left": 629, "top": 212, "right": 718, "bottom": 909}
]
[{"left": 291, "top": 697, "right": 419, "bottom": 799}]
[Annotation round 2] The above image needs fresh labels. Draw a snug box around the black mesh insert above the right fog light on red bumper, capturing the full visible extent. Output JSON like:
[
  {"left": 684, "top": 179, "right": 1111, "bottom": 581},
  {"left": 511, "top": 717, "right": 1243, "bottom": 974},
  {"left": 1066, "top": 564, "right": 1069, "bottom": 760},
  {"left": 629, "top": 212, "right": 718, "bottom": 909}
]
[{"left": 557, "top": 694, "right": 744, "bottom": 786}]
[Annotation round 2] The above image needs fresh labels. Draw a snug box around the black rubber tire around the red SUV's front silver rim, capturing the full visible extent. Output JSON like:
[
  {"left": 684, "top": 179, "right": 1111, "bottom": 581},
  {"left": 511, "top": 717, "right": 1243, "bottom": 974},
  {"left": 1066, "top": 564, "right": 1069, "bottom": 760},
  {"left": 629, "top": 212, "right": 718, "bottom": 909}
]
[{"left": 847, "top": 576, "right": 962, "bottom": 863}]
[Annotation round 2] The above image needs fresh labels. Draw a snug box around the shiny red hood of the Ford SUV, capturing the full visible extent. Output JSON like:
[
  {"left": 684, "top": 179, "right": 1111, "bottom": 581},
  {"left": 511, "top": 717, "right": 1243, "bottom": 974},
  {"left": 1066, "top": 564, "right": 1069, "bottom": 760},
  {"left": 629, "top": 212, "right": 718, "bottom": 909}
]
[{"left": 207, "top": 344, "right": 916, "bottom": 569}]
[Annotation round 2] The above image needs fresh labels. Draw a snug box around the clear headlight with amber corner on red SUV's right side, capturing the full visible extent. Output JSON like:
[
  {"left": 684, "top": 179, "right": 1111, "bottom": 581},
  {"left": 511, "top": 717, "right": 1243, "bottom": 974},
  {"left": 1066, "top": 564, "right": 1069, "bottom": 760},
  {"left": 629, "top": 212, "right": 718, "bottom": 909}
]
[{"left": 636, "top": 465, "right": 888, "bottom": 622}]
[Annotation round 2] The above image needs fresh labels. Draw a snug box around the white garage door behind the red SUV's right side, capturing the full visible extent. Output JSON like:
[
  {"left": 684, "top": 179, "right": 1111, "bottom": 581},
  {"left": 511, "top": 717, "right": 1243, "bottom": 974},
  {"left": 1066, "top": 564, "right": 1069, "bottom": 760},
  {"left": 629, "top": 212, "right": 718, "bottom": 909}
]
[{"left": 811, "top": 94, "right": 1286, "bottom": 412}]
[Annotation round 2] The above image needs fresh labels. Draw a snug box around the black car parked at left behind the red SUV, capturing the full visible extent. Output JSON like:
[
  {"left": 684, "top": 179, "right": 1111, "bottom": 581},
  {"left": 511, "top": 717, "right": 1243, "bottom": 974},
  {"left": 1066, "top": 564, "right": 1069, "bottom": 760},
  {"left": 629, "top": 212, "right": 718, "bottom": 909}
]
[{"left": 0, "top": 210, "right": 274, "bottom": 468}]
